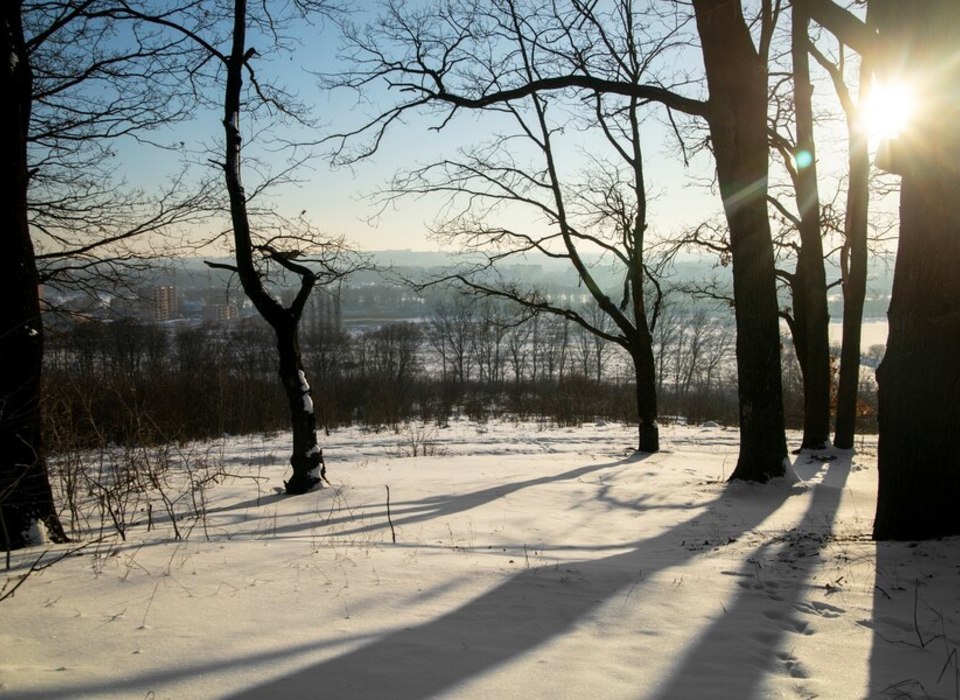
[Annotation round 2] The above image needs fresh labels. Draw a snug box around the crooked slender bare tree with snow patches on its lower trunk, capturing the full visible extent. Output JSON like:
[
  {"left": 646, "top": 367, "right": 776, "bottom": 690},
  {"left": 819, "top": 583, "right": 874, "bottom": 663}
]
[{"left": 102, "top": 0, "right": 364, "bottom": 494}]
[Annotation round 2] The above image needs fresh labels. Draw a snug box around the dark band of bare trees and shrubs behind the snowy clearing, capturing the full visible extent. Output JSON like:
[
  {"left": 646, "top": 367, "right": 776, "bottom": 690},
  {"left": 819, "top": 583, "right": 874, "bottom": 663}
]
[{"left": 45, "top": 296, "right": 875, "bottom": 450}]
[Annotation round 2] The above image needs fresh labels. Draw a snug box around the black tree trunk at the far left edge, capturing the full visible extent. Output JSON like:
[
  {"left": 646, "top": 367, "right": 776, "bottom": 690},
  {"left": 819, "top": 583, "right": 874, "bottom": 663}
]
[{"left": 0, "top": 2, "right": 66, "bottom": 551}]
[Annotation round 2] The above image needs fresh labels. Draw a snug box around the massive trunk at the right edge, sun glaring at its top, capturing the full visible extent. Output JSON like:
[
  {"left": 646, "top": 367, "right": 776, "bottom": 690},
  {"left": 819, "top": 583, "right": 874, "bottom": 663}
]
[{"left": 871, "top": 0, "right": 960, "bottom": 540}]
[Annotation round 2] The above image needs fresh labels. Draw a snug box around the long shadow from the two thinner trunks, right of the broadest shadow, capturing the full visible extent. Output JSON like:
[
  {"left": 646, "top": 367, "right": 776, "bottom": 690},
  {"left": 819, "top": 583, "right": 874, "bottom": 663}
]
[{"left": 655, "top": 455, "right": 852, "bottom": 700}]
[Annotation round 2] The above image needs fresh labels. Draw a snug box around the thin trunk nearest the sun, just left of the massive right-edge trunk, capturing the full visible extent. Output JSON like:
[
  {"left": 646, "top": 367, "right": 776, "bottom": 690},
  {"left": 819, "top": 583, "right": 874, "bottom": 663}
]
[{"left": 833, "top": 56, "right": 870, "bottom": 450}]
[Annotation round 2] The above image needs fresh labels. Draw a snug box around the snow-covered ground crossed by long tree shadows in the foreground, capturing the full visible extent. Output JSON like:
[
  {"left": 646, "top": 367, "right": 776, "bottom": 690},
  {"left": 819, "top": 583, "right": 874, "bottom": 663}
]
[{"left": 0, "top": 422, "right": 960, "bottom": 700}]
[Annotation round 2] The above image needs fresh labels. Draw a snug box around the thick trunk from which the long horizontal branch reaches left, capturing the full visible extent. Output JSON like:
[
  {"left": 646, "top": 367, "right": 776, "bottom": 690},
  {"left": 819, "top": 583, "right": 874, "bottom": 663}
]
[{"left": 693, "top": 0, "right": 787, "bottom": 481}]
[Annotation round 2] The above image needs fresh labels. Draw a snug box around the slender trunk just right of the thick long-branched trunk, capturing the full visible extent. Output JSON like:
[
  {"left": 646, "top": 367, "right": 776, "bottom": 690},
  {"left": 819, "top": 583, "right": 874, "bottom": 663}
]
[{"left": 792, "top": 7, "right": 830, "bottom": 450}]
